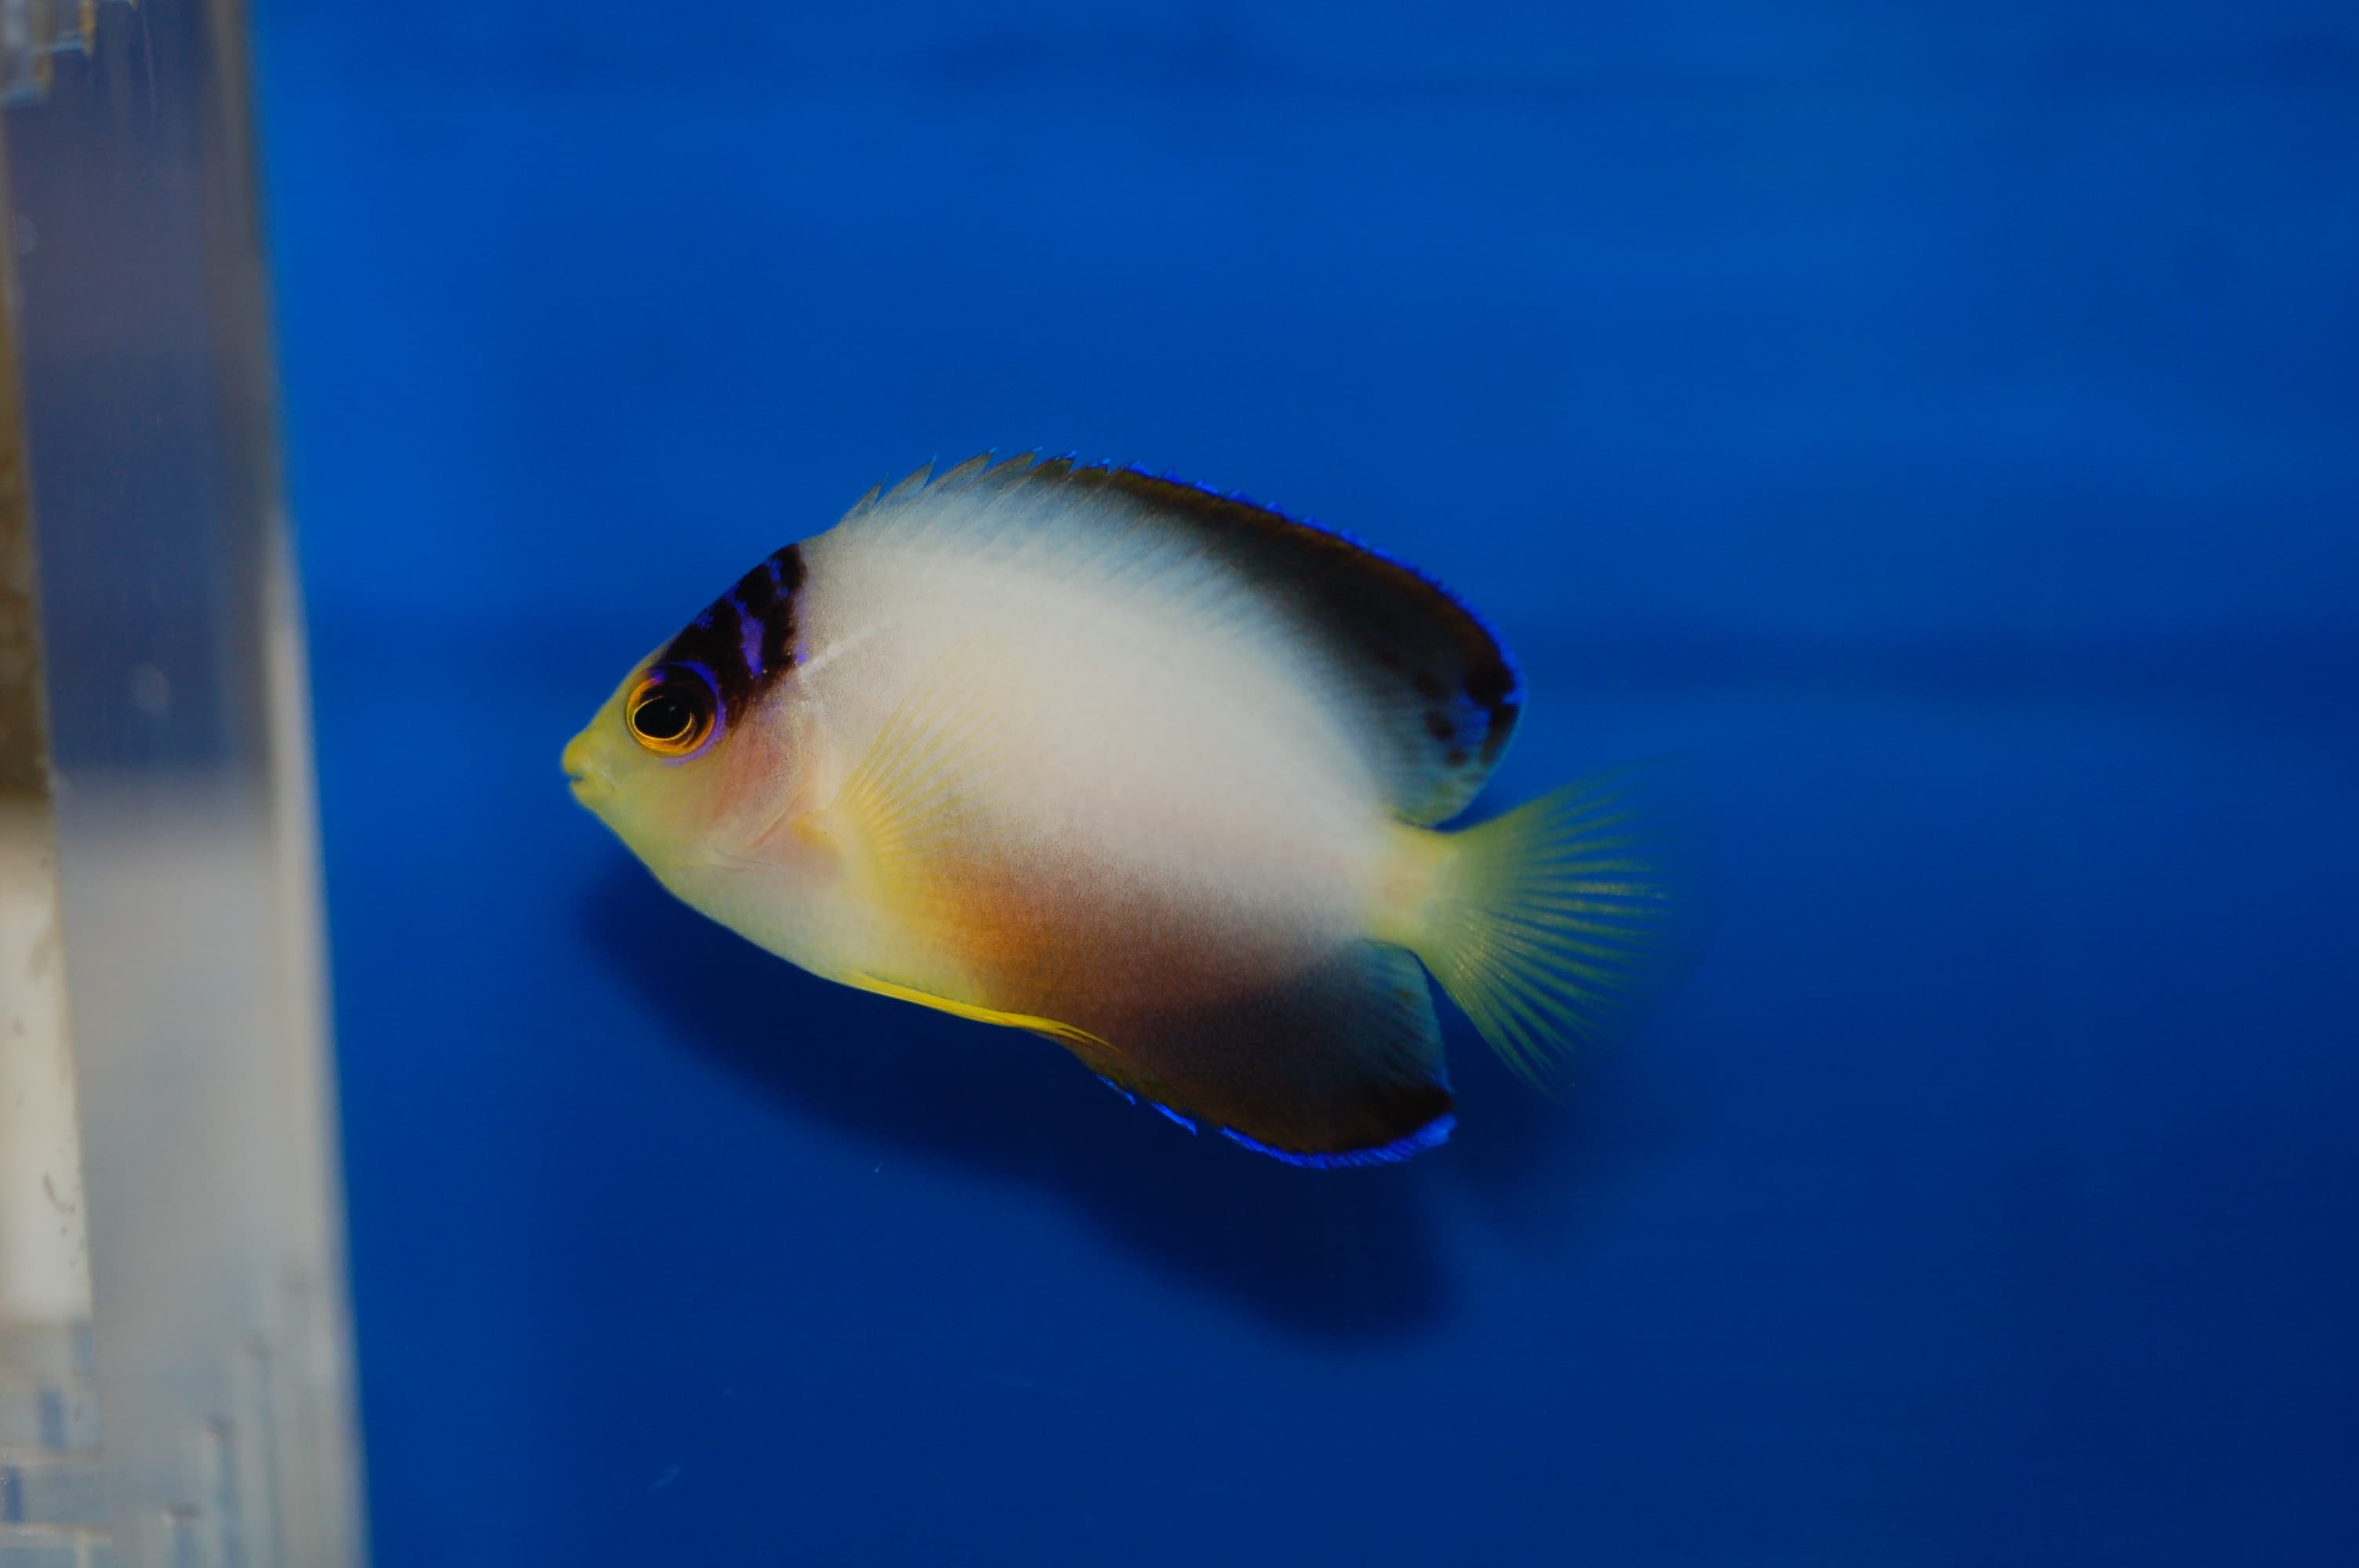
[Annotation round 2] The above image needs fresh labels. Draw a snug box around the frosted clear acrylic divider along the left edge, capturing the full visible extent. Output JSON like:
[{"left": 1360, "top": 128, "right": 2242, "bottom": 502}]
[{"left": 0, "top": 0, "right": 363, "bottom": 1568}]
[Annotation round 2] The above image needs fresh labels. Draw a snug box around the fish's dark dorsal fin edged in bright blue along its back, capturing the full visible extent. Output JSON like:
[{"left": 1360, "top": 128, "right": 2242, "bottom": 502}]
[{"left": 842, "top": 452, "right": 1524, "bottom": 826}]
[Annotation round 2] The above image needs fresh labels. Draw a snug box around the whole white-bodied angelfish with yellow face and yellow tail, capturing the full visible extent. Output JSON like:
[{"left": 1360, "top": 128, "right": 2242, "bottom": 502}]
[{"left": 562, "top": 452, "right": 1682, "bottom": 1167}]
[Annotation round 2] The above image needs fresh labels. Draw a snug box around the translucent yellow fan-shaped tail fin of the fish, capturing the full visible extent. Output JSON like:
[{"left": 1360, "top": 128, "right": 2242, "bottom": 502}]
[{"left": 1394, "top": 768, "right": 1694, "bottom": 1084}]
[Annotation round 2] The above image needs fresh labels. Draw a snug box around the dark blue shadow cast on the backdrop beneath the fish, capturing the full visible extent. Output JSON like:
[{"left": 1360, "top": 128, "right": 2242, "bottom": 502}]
[{"left": 583, "top": 866, "right": 1623, "bottom": 1339}]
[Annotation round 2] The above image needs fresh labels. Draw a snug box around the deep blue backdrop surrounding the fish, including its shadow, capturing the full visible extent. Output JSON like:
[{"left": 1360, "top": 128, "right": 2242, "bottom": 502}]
[{"left": 260, "top": 0, "right": 2359, "bottom": 1568}]
